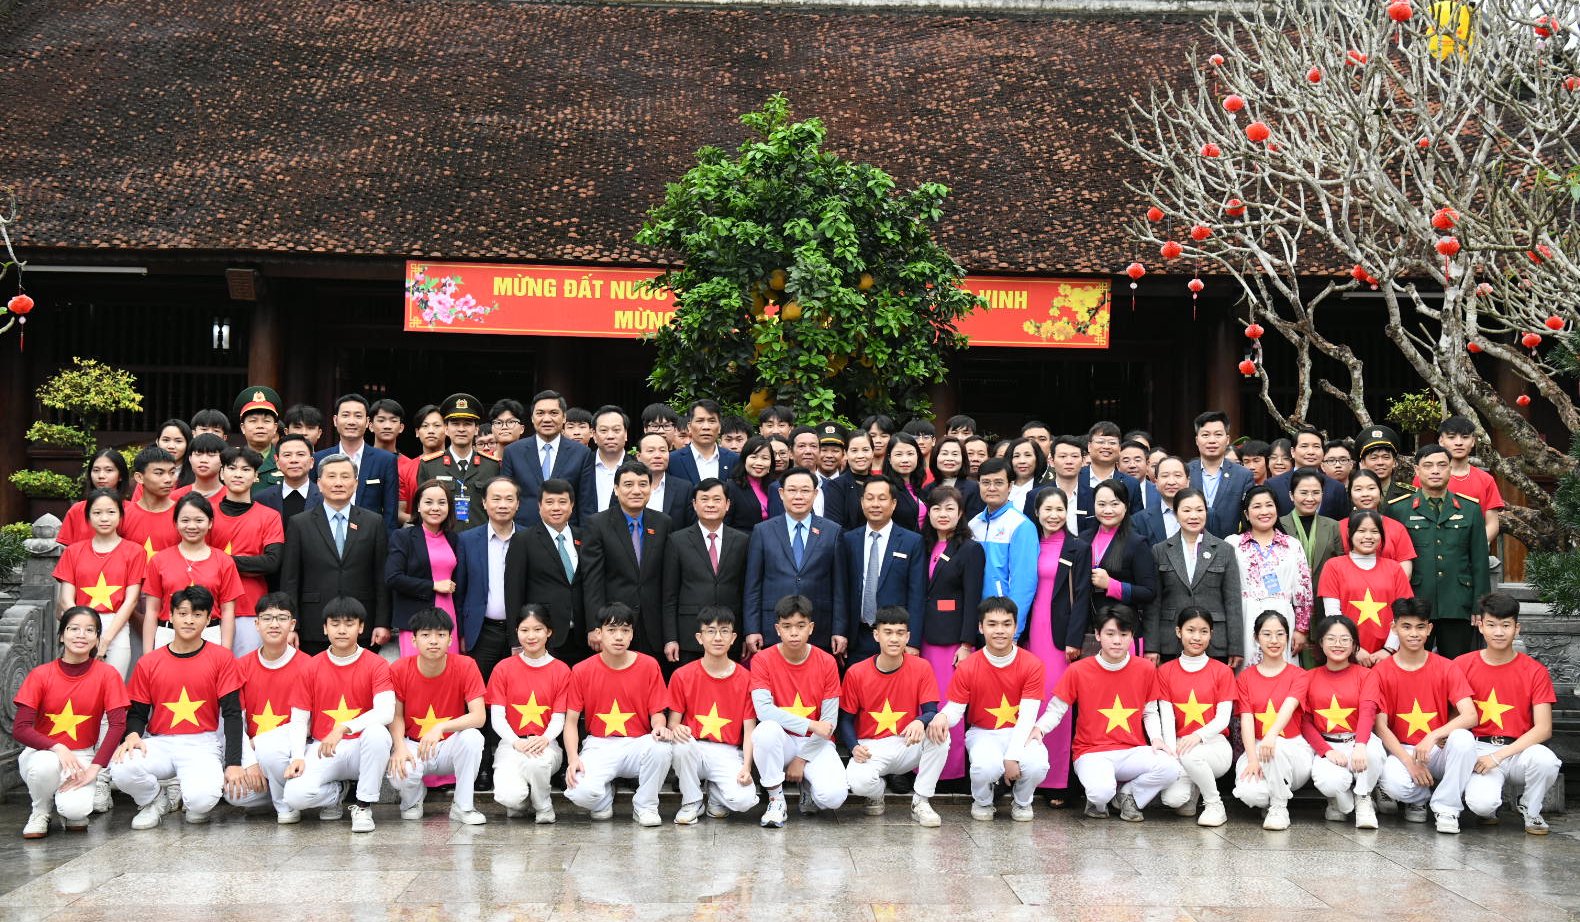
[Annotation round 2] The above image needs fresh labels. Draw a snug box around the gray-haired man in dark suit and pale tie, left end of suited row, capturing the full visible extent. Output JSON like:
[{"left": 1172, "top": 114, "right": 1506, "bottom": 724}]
[{"left": 280, "top": 455, "right": 390, "bottom": 654}]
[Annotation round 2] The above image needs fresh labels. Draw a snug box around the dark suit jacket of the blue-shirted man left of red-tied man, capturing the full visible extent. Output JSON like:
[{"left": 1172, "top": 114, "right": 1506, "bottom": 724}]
[{"left": 587, "top": 504, "right": 670, "bottom": 657}]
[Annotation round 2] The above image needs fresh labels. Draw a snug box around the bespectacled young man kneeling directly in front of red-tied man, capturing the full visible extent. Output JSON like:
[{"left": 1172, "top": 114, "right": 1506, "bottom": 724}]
[{"left": 670, "top": 605, "right": 757, "bottom": 826}]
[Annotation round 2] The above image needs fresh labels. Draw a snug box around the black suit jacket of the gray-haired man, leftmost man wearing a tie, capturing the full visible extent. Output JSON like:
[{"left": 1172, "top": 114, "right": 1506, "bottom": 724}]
[{"left": 280, "top": 504, "right": 390, "bottom": 647}]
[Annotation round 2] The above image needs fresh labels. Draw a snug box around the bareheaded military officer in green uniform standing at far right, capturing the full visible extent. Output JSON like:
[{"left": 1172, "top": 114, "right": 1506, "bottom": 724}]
[{"left": 1386, "top": 444, "right": 1492, "bottom": 660}]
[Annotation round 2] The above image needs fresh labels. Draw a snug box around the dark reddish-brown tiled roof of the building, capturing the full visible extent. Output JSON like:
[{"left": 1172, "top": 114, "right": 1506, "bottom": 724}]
[{"left": 0, "top": 0, "right": 1201, "bottom": 273}]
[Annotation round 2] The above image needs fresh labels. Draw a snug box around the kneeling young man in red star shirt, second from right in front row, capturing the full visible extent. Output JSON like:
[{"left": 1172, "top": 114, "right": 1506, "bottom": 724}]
[{"left": 1365, "top": 598, "right": 1476, "bottom": 834}]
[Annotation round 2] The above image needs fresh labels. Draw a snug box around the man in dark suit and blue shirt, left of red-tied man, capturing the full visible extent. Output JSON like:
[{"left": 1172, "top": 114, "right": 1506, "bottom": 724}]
[{"left": 581, "top": 461, "right": 670, "bottom": 658}]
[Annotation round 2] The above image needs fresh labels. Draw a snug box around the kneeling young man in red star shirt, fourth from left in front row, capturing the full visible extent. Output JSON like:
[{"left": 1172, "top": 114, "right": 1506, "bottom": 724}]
[{"left": 286, "top": 595, "right": 395, "bottom": 832}]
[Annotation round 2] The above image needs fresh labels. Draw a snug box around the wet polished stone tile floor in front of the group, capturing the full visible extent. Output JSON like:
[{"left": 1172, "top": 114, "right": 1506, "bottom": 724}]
[{"left": 0, "top": 796, "right": 1580, "bottom": 922}]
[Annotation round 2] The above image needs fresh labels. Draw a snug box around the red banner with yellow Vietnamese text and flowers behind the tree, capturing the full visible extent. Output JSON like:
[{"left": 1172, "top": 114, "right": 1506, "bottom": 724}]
[{"left": 404, "top": 260, "right": 1111, "bottom": 349}]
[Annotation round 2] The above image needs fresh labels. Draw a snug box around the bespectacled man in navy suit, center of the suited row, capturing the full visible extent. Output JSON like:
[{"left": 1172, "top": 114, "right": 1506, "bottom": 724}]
[{"left": 743, "top": 467, "right": 847, "bottom": 655}]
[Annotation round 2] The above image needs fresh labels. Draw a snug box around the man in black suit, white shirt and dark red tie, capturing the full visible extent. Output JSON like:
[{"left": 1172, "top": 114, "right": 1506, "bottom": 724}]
[{"left": 664, "top": 477, "right": 751, "bottom": 663}]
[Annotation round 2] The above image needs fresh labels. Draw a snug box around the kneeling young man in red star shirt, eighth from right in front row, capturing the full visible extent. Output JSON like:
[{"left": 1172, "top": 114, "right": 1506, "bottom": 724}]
[{"left": 839, "top": 605, "right": 950, "bottom": 826}]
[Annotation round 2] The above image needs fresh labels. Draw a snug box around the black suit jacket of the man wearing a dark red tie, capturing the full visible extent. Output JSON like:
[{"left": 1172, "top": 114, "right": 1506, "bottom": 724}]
[{"left": 664, "top": 526, "right": 751, "bottom": 652}]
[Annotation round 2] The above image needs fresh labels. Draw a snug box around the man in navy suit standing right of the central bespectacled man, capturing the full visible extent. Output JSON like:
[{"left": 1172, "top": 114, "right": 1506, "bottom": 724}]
[{"left": 834, "top": 477, "right": 927, "bottom": 663}]
